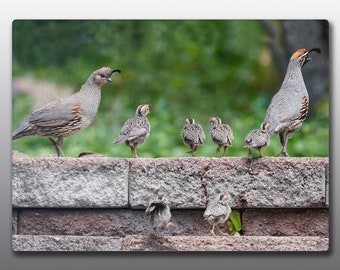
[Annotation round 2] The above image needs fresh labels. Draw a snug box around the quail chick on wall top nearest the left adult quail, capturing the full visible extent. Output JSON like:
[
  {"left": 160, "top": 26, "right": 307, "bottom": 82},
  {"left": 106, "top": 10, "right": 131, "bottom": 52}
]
[{"left": 112, "top": 104, "right": 151, "bottom": 158}]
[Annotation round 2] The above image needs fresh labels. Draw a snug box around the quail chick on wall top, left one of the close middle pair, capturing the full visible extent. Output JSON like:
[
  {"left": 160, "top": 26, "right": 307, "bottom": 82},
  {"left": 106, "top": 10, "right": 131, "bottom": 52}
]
[{"left": 181, "top": 118, "right": 205, "bottom": 157}]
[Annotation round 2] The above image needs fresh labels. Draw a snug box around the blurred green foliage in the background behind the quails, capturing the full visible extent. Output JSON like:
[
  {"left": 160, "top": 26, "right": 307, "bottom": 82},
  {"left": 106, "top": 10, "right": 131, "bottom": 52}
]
[{"left": 12, "top": 20, "right": 329, "bottom": 157}]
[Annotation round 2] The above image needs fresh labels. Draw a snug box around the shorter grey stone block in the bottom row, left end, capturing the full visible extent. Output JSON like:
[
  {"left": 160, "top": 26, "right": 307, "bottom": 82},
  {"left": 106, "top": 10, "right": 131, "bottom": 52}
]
[{"left": 12, "top": 235, "right": 122, "bottom": 251}]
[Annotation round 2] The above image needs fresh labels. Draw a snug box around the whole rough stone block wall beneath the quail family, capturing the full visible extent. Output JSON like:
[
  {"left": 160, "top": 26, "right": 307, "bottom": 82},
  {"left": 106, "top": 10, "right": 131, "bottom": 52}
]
[{"left": 12, "top": 152, "right": 329, "bottom": 251}]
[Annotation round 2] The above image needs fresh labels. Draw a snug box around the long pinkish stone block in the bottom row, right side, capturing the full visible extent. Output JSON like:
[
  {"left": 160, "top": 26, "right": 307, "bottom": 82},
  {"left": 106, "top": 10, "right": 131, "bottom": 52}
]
[{"left": 122, "top": 235, "right": 329, "bottom": 251}]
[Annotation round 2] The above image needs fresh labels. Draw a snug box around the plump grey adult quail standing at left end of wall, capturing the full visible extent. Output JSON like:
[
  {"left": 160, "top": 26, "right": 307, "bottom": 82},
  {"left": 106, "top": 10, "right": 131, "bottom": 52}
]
[{"left": 12, "top": 67, "right": 120, "bottom": 157}]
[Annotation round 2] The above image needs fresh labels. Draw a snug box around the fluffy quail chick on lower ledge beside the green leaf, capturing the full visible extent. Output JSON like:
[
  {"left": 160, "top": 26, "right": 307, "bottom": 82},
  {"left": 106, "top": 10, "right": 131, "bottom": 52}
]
[{"left": 203, "top": 193, "right": 231, "bottom": 235}]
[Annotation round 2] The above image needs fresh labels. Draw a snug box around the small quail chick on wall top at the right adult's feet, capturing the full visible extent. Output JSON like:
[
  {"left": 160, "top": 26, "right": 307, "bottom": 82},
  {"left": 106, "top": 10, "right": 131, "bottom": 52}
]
[{"left": 244, "top": 122, "right": 270, "bottom": 158}]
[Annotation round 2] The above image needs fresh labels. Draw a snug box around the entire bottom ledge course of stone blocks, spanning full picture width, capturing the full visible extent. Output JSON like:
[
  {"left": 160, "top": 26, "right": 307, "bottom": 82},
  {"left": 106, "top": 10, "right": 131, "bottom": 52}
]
[{"left": 12, "top": 235, "right": 329, "bottom": 252}]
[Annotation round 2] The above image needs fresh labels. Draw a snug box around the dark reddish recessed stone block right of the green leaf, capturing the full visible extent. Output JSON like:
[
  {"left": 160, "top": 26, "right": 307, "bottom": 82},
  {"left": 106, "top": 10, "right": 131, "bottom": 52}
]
[{"left": 242, "top": 209, "right": 329, "bottom": 237}]
